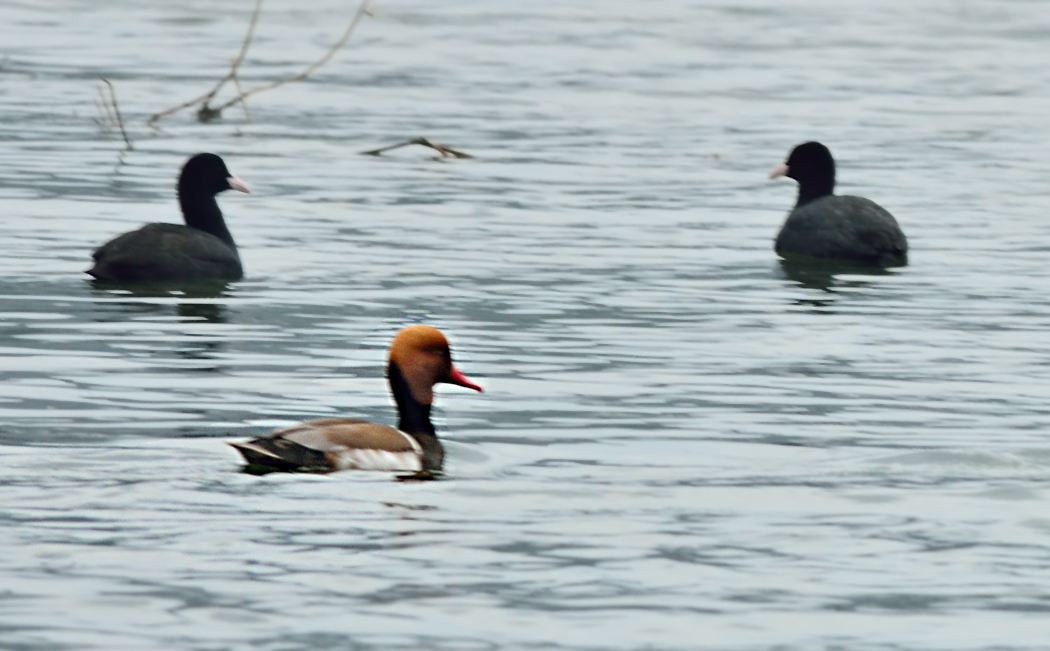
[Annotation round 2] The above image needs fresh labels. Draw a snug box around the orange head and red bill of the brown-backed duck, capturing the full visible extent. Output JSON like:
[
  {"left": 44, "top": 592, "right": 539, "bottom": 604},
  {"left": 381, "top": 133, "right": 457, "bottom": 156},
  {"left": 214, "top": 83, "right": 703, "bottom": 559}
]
[{"left": 389, "top": 326, "right": 481, "bottom": 404}]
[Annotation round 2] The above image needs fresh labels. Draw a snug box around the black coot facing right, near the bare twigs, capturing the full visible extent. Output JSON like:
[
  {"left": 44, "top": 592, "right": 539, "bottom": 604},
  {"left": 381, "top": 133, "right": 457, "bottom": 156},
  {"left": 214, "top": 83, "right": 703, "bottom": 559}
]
[{"left": 87, "top": 153, "right": 249, "bottom": 282}]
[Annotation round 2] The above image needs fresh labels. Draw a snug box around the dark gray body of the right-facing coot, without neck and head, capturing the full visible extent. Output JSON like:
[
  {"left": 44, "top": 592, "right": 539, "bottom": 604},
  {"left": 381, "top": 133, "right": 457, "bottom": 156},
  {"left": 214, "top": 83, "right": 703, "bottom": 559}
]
[{"left": 87, "top": 224, "right": 244, "bottom": 282}]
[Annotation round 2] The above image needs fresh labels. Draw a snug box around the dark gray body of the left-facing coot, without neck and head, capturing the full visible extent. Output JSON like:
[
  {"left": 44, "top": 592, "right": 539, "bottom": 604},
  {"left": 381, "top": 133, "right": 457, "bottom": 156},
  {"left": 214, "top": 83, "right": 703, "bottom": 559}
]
[{"left": 776, "top": 194, "right": 908, "bottom": 267}]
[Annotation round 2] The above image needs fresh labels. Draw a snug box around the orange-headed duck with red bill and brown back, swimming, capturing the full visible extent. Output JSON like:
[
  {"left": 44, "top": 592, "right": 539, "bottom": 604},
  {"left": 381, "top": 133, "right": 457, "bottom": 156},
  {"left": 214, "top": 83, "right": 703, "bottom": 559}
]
[{"left": 229, "top": 324, "right": 482, "bottom": 476}]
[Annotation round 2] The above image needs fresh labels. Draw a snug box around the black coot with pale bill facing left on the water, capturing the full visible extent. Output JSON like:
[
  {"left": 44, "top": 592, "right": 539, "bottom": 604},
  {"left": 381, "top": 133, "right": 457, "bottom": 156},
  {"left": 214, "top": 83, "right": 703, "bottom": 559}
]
[{"left": 770, "top": 142, "right": 908, "bottom": 267}]
